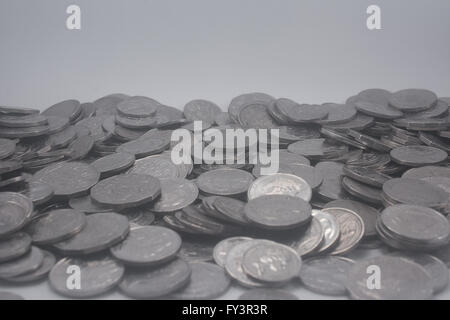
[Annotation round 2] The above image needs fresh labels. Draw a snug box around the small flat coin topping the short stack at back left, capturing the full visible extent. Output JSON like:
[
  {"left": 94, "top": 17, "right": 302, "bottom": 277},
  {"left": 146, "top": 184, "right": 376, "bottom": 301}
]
[{"left": 116, "top": 96, "right": 160, "bottom": 118}]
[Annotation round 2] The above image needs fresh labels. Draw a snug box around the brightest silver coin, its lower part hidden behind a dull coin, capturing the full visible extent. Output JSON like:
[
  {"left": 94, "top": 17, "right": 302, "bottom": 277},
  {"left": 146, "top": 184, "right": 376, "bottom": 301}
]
[{"left": 247, "top": 173, "right": 312, "bottom": 202}]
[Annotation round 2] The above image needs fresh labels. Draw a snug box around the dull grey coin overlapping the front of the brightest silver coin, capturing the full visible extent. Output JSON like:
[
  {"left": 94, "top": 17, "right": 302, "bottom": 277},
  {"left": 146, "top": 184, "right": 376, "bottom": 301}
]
[{"left": 244, "top": 195, "right": 311, "bottom": 230}]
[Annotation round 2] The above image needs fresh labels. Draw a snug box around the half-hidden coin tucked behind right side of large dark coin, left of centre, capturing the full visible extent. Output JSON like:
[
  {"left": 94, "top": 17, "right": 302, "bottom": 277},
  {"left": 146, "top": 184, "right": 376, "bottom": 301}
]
[{"left": 152, "top": 179, "right": 198, "bottom": 212}]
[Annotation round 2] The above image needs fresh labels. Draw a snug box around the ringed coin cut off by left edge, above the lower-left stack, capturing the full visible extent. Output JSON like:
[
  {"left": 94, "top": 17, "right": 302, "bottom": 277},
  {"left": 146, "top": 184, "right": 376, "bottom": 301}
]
[{"left": 0, "top": 192, "right": 34, "bottom": 236}]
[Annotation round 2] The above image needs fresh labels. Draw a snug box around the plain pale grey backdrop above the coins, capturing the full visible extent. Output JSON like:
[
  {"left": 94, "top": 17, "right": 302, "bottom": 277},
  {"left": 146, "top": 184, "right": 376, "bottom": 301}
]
[{"left": 0, "top": 0, "right": 450, "bottom": 108}]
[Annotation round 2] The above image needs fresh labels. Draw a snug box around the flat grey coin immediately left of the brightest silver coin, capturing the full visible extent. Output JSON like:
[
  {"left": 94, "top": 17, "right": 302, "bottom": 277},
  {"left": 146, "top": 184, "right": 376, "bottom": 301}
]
[{"left": 196, "top": 169, "right": 253, "bottom": 196}]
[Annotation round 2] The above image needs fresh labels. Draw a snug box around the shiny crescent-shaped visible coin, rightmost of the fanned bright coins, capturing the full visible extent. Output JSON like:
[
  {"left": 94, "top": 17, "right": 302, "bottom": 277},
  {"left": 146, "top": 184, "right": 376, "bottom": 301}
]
[{"left": 322, "top": 208, "right": 364, "bottom": 255}]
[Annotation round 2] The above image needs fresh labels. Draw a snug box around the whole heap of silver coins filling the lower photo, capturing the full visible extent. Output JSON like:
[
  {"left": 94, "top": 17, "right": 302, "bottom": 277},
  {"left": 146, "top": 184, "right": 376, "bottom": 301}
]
[{"left": 0, "top": 89, "right": 450, "bottom": 300}]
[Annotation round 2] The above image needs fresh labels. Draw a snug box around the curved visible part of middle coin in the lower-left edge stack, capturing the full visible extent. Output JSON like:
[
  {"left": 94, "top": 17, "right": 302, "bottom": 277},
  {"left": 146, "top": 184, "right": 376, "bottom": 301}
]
[{"left": 0, "top": 246, "right": 44, "bottom": 278}]
